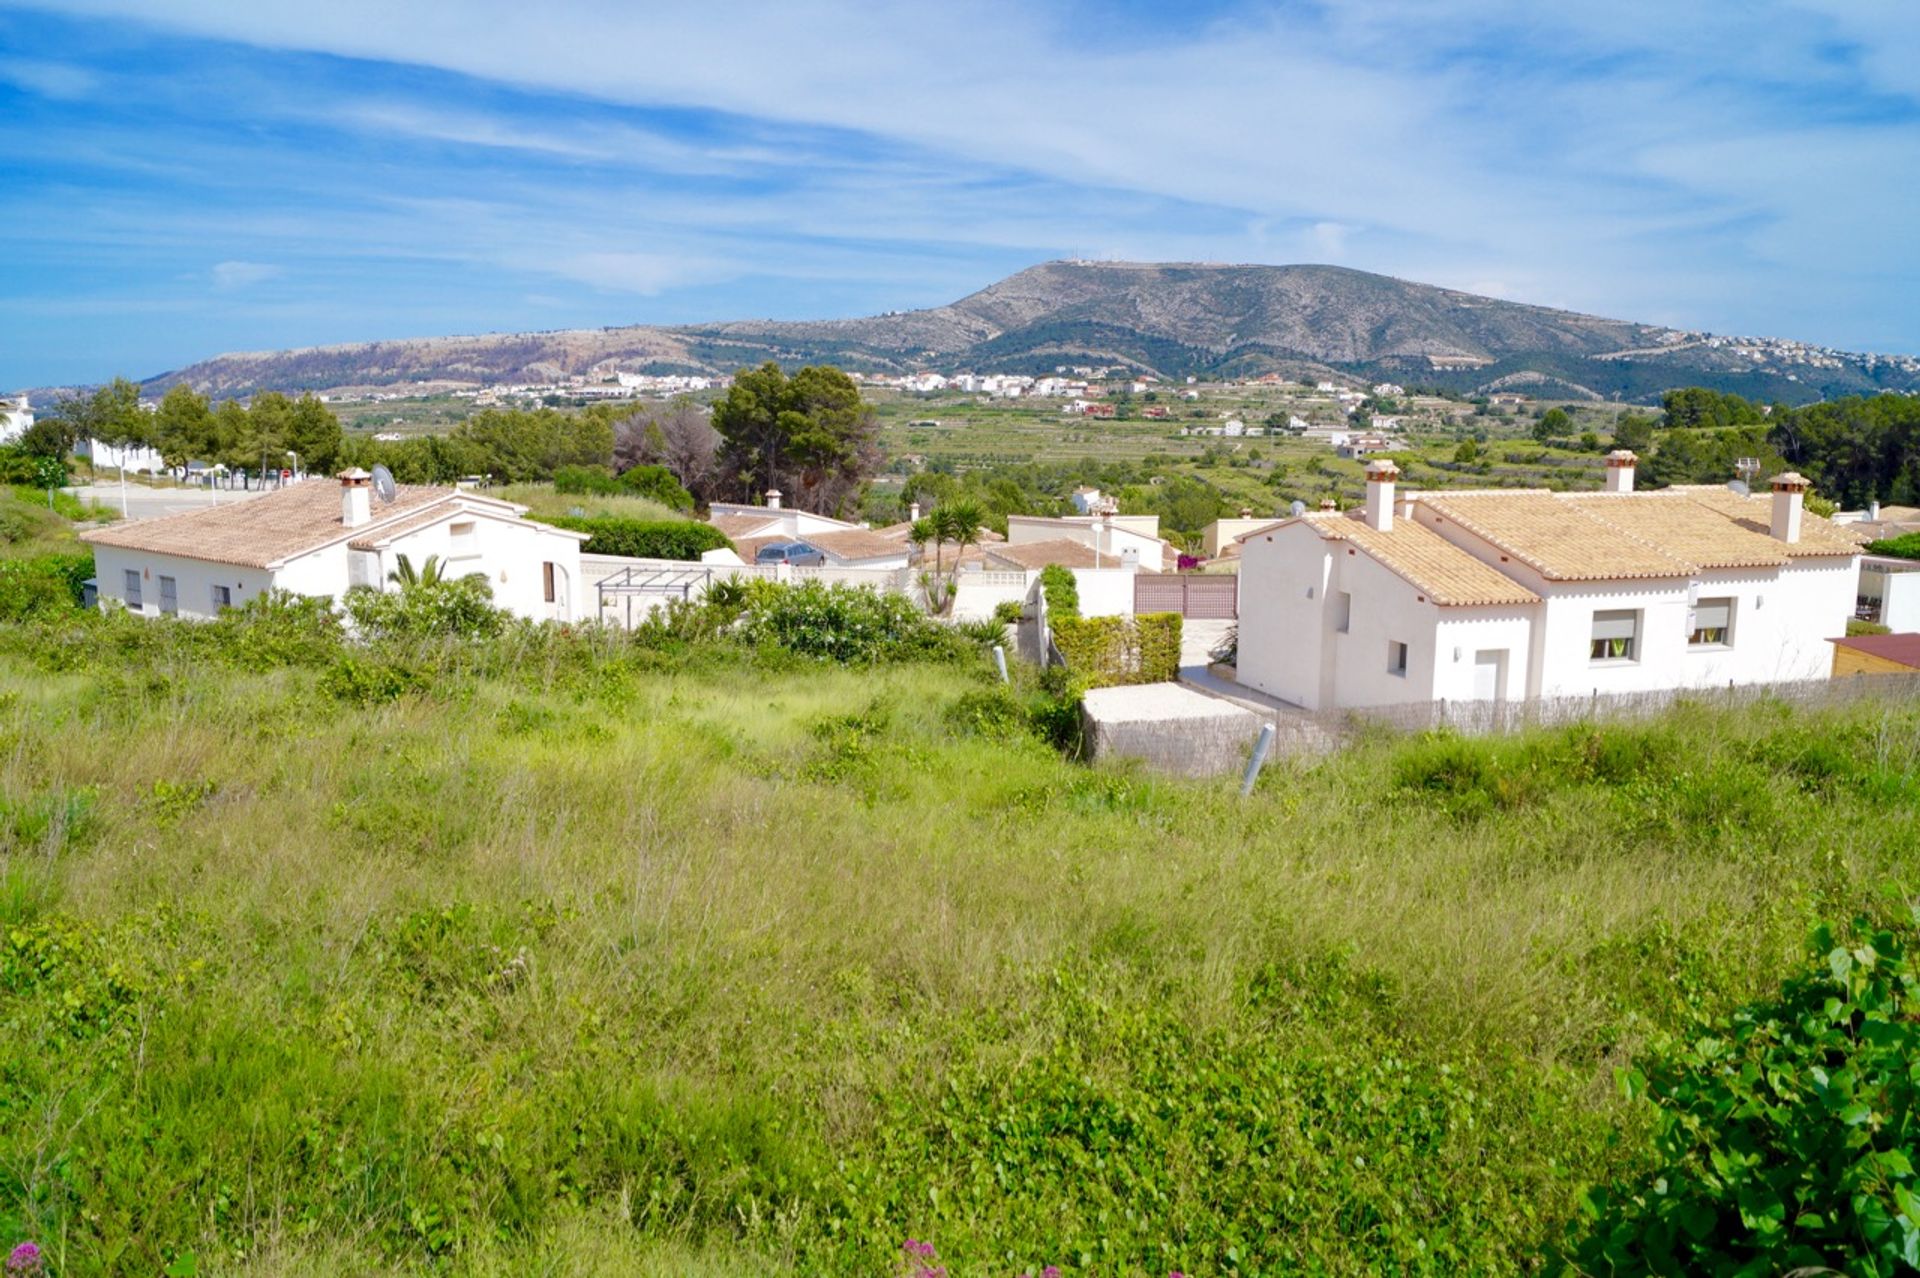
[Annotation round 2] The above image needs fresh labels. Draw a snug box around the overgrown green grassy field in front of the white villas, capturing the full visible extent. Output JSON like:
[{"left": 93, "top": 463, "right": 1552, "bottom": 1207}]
[{"left": 0, "top": 598, "right": 1920, "bottom": 1278}]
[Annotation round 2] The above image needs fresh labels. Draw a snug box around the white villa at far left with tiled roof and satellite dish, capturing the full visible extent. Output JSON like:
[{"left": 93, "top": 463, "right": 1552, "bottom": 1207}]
[{"left": 83, "top": 470, "right": 591, "bottom": 622}]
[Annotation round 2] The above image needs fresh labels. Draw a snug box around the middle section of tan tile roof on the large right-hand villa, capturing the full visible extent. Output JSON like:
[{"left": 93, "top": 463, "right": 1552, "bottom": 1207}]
[{"left": 1417, "top": 489, "right": 1695, "bottom": 581}]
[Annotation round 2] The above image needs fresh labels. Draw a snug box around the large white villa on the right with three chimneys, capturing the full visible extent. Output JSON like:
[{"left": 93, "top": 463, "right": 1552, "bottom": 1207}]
[{"left": 1238, "top": 451, "right": 1860, "bottom": 710}]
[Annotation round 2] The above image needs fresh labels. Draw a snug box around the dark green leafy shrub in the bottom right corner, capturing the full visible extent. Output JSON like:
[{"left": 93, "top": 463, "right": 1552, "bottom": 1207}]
[{"left": 1571, "top": 911, "right": 1920, "bottom": 1278}]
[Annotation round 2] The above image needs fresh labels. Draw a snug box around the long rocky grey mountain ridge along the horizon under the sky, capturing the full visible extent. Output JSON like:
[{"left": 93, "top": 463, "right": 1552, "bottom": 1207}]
[{"left": 150, "top": 261, "right": 1920, "bottom": 401}]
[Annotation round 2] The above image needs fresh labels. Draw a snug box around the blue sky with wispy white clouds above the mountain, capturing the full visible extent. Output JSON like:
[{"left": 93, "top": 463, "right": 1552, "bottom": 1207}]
[{"left": 0, "top": 0, "right": 1920, "bottom": 388}]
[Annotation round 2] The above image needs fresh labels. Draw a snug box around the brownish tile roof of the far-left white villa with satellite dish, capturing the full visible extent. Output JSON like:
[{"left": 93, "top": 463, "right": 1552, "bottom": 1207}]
[{"left": 81, "top": 480, "right": 456, "bottom": 568}]
